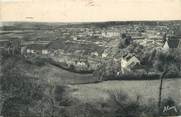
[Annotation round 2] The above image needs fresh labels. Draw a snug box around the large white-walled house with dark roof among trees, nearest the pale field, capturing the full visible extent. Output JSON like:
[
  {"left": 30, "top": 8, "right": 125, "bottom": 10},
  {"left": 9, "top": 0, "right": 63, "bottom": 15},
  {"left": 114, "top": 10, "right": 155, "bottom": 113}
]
[{"left": 121, "top": 54, "right": 140, "bottom": 73}]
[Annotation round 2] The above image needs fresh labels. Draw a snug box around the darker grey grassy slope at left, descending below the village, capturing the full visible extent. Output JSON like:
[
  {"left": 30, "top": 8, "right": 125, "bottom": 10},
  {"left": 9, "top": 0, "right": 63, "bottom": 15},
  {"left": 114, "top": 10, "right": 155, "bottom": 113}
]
[{"left": 0, "top": 57, "right": 97, "bottom": 85}]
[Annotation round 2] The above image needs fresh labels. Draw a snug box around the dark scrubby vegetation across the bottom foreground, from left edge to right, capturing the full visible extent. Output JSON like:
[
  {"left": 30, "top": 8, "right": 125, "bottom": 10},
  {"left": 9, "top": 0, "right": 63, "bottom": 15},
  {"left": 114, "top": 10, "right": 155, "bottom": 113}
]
[{"left": 0, "top": 48, "right": 180, "bottom": 117}]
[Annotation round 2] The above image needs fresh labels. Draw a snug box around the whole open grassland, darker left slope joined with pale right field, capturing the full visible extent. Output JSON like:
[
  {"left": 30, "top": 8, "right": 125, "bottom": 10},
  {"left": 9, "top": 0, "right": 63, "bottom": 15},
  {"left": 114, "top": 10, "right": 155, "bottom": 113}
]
[{"left": 2, "top": 55, "right": 181, "bottom": 106}]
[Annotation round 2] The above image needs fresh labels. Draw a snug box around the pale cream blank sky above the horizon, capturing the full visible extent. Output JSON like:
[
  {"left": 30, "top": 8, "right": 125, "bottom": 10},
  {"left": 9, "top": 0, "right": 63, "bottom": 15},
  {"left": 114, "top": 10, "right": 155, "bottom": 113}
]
[{"left": 0, "top": 0, "right": 181, "bottom": 22}]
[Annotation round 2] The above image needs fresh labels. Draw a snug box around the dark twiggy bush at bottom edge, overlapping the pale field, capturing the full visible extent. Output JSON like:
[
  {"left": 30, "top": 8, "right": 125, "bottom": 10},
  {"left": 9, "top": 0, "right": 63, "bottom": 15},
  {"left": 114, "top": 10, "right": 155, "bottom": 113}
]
[{"left": 107, "top": 91, "right": 158, "bottom": 117}]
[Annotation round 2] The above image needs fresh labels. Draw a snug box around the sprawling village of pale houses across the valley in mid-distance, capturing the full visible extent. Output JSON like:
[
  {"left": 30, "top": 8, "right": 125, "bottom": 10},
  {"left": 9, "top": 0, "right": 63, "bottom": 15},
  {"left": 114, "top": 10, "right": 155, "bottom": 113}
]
[{"left": 0, "top": 21, "right": 181, "bottom": 74}]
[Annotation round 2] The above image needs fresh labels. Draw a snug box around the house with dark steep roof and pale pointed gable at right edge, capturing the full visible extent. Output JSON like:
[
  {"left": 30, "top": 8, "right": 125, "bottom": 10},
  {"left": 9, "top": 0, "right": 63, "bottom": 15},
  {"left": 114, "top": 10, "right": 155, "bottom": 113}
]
[{"left": 162, "top": 38, "right": 181, "bottom": 51}]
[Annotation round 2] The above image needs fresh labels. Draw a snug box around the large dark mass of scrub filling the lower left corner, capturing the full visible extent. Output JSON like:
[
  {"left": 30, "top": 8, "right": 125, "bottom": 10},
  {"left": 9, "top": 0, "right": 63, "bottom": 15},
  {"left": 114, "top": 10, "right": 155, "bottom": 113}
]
[{"left": 0, "top": 56, "right": 72, "bottom": 117}]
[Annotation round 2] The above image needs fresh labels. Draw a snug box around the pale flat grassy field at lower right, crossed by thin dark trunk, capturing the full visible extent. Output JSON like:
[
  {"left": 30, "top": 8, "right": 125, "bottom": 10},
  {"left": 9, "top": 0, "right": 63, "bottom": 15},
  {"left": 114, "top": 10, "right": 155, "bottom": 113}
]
[{"left": 69, "top": 79, "right": 181, "bottom": 104}]
